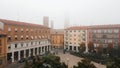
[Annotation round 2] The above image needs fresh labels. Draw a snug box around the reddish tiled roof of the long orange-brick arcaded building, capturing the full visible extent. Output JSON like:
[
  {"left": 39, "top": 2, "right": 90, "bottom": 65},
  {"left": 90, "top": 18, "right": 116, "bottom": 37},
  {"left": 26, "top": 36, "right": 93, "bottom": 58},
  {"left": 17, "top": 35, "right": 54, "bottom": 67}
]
[{"left": 0, "top": 19, "right": 48, "bottom": 28}]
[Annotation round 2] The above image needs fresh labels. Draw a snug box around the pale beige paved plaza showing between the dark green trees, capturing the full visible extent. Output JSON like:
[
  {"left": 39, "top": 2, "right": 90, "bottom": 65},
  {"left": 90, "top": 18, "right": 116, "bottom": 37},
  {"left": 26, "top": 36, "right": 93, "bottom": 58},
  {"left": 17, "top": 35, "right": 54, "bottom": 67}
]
[{"left": 57, "top": 53, "right": 106, "bottom": 68}]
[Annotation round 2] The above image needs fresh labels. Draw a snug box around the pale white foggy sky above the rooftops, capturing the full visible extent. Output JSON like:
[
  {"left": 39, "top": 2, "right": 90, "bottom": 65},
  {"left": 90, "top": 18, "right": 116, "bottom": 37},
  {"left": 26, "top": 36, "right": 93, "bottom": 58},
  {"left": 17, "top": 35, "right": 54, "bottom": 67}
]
[{"left": 0, "top": 0, "right": 120, "bottom": 28}]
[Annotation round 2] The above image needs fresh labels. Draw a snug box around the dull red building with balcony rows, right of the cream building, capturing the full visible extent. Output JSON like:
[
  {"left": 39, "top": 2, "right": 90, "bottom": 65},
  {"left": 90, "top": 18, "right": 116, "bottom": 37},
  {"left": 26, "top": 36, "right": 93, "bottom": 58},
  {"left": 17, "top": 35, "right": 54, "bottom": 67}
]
[{"left": 89, "top": 24, "right": 120, "bottom": 48}]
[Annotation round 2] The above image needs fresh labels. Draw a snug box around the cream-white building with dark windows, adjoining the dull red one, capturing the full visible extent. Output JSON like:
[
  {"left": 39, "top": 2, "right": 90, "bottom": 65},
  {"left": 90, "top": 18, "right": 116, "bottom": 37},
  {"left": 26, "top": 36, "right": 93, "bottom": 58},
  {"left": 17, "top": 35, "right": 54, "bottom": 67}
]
[{"left": 64, "top": 26, "right": 88, "bottom": 52}]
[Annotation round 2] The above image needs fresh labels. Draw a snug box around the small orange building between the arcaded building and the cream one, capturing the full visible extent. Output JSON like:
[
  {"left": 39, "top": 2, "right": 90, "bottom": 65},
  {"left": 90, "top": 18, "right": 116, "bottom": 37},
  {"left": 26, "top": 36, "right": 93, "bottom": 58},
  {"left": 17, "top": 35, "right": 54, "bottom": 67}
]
[{"left": 51, "top": 29, "right": 64, "bottom": 48}]
